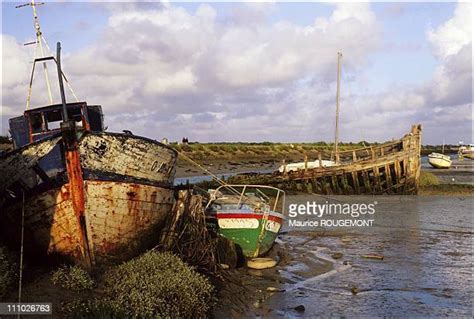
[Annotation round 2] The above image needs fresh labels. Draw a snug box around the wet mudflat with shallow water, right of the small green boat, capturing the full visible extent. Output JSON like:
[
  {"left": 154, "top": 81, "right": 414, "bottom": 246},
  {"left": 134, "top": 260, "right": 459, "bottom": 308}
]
[{"left": 228, "top": 195, "right": 473, "bottom": 318}]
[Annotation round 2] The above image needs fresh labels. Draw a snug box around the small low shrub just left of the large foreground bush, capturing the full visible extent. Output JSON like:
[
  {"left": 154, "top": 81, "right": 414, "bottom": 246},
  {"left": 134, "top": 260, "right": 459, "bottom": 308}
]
[{"left": 51, "top": 266, "right": 94, "bottom": 291}]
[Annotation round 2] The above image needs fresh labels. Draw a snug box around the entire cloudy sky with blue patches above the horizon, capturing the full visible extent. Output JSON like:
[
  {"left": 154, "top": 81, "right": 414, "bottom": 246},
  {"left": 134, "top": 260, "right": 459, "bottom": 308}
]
[{"left": 1, "top": 2, "right": 473, "bottom": 144}]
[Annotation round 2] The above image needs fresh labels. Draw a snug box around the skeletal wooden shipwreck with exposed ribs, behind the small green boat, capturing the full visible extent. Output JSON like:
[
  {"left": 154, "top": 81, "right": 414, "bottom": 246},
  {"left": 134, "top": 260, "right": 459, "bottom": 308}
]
[{"left": 230, "top": 125, "right": 421, "bottom": 195}]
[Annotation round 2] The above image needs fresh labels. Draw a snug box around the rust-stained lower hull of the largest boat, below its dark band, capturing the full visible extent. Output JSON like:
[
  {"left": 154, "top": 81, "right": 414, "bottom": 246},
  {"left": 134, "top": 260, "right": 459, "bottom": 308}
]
[{"left": 2, "top": 181, "right": 174, "bottom": 263}]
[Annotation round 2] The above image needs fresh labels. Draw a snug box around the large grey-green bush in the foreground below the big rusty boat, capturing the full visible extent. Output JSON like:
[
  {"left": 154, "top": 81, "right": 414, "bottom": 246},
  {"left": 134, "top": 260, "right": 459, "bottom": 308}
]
[{"left": 64, "top": 251, "right": 214, "bottom": 318}]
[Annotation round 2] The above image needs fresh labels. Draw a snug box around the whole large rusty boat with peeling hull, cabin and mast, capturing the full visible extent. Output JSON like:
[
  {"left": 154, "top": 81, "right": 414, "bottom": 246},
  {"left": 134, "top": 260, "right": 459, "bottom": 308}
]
[{"left": 0, "top": 16, "right": 177, "bottom": 267}]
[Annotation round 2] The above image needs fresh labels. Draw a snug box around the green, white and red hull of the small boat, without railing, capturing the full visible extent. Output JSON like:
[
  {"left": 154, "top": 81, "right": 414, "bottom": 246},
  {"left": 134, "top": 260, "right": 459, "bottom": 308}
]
[{"left": 208, "top": 211, "right": 284, "bottom": 257}]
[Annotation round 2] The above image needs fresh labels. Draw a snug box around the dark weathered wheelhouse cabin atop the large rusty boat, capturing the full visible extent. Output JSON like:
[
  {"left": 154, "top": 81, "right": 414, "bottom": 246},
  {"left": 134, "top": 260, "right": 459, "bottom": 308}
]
[{"left": 9, "top": 102, "right": 104, "bottom": 148}]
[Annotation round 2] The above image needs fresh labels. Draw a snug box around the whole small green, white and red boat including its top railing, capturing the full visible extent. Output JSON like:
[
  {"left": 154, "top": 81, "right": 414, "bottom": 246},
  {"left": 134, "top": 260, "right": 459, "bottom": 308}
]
[{"left": 206, "top": 185, "right": 285, "bottom": 257}]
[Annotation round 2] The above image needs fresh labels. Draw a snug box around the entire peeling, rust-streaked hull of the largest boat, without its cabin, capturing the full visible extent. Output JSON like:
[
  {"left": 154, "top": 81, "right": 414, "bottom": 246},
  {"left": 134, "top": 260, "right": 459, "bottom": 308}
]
[{"left": 0, "top": 132, "right": 177, "bottom": 265}]
